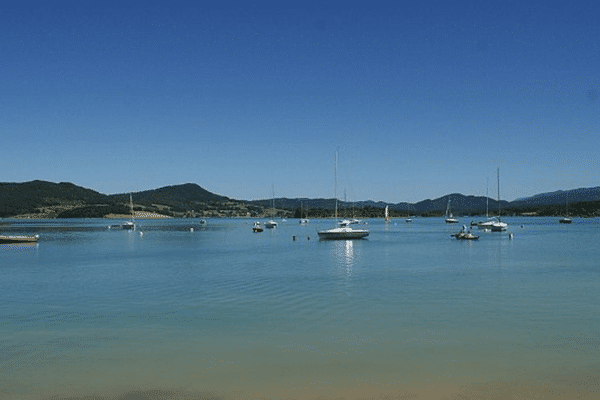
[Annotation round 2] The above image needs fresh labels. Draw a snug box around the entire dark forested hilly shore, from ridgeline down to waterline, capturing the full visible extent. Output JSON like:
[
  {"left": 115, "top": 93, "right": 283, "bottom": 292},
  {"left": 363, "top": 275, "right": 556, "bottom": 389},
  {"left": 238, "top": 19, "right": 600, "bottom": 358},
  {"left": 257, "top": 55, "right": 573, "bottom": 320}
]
[{"left": 0, "top": 180, "right": 600, "bottom": 218}]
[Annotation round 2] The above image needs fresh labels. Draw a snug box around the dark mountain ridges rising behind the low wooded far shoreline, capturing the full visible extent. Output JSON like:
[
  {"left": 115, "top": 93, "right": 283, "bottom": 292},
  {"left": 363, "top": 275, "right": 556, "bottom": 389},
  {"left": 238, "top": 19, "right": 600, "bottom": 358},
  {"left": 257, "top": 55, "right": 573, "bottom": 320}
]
[{"left": 0, "top": 180, "right": 600, "bottom": 217}]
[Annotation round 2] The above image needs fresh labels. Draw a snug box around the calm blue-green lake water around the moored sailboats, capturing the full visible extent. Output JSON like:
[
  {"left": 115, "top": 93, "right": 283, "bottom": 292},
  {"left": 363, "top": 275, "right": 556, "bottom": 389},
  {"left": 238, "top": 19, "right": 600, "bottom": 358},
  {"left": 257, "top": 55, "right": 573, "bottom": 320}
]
[{"left": 0, "top": 218, "right": 600, "bottom": 400}]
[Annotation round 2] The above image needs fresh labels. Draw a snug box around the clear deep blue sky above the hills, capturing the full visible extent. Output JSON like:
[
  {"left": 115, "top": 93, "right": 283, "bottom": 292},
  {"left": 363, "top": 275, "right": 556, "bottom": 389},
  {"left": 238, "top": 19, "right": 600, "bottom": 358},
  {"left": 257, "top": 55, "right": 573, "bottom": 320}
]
[{"left": 0, "top": 1, "right": 600, "bottom": 203}]
